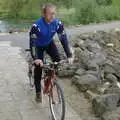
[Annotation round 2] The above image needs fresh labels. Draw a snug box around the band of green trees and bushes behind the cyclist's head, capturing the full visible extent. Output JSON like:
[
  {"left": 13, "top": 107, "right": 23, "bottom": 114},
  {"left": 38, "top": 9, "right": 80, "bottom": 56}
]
[{"left": 0, "top": 0, "right": 120, "bottom": 24}]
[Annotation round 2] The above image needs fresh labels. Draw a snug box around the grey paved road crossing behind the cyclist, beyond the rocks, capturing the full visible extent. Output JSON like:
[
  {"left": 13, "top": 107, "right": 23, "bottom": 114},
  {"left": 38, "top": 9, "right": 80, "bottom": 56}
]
[{"left": 0, "top": 21, "right": 120, "bottom": 48}]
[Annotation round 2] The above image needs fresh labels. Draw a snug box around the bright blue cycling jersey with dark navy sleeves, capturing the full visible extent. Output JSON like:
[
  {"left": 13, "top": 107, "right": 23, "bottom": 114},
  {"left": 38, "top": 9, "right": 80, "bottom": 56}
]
[{"left": 30, "top": 17, "right": 71, "bottom": 57}]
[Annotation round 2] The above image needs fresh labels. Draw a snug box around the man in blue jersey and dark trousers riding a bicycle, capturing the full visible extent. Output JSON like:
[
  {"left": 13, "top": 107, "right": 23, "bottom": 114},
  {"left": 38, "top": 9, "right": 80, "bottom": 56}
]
[{"left": 30, "top": 4, "right": 72, "bottom": 102}]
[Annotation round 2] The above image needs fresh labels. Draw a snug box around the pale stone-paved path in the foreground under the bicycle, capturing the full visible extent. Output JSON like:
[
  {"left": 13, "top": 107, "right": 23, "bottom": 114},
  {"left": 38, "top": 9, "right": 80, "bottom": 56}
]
[{"left": 0, "top": 41, "right": 81, "bottom": 120}]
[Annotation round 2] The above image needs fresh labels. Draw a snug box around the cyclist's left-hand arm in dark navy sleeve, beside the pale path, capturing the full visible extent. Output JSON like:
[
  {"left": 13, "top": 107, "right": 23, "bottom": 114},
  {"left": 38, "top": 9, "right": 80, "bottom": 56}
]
[{"left": 29, "top": 24, "right": 39, "bottom": 60}]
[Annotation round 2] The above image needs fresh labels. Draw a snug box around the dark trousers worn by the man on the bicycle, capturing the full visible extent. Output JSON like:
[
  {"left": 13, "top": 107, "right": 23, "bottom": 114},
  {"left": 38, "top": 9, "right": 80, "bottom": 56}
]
[{"left": 34, "top": 41, "right": 60, "bottom": 92}]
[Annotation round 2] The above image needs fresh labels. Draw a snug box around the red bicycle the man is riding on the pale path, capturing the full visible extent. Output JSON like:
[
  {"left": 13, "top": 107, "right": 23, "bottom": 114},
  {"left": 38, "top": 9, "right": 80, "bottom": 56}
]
[{"left": 26, "top": 49, "right": 66, "bottom": 120}]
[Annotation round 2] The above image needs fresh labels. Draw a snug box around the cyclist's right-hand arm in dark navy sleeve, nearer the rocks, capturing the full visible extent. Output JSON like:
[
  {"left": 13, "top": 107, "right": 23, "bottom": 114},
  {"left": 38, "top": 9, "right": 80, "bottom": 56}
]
[{"left": 57, "top": 21, "right": 72, "bottom": 58}]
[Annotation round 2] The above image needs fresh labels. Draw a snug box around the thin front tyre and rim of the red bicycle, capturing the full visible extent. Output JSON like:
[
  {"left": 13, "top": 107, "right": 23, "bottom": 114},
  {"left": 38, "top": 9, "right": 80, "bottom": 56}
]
[{"left": 49, "top": 80, "right": 65, "bottom": 120}]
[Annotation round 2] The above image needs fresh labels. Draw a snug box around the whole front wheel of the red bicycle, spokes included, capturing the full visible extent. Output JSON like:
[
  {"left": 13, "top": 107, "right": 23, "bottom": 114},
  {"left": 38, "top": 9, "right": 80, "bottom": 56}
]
[{"left": 49, "top": 80, "right": 65, "bottom": 120}]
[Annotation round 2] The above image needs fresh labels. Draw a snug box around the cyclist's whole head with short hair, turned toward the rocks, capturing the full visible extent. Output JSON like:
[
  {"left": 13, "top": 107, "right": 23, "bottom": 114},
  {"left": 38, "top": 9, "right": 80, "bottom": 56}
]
[{"left": 42, "top": 4, "right": 56, "bottom": 23}]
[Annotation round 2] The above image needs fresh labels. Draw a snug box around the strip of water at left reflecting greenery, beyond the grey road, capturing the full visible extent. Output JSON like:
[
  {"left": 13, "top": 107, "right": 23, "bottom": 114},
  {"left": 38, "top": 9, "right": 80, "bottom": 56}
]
[{"left": 0, "top": 20, "right": 32, "bottom": 32}]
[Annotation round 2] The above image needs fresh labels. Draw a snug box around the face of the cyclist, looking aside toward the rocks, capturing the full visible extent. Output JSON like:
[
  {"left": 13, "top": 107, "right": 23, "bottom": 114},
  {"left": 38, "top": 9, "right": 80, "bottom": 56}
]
[{"left": 44, "top": 7, "right": 56, "bottom": 23}]
